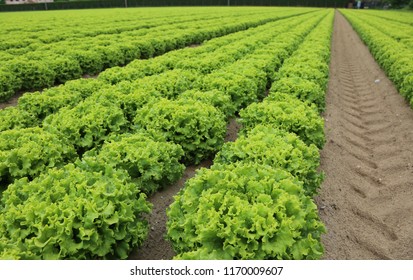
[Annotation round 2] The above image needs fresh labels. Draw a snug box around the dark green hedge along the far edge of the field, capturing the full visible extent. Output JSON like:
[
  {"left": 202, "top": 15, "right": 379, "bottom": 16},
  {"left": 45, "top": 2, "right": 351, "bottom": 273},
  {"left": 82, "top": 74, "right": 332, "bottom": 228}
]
[{"left": 0, "top": 0, "right": 347, "bottom": 12}]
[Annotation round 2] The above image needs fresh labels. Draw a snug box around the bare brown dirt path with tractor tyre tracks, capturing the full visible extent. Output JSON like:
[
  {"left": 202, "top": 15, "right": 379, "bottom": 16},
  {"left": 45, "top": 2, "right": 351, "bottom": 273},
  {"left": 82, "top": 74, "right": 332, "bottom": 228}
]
[{"left": 317, "top": 10, "right": 413, "bottom": 259}]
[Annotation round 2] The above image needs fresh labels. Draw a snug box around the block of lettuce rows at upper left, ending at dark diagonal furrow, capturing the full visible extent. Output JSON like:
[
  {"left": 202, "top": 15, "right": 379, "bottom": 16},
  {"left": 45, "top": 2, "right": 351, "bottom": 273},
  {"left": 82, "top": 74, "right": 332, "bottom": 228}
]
[{"left": 0, "top": 8, "right": 311, "bottom": 101}]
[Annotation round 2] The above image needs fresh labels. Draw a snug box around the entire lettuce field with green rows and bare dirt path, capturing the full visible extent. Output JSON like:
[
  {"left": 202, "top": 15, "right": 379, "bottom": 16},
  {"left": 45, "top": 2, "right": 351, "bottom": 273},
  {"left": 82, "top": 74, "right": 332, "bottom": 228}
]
[{"left": 0, "top": 7, "right": 413, "bottom": 259}]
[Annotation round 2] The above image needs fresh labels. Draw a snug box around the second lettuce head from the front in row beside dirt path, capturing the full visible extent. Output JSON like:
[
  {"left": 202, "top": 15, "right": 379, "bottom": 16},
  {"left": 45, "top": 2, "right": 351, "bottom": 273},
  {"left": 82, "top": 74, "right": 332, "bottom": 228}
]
[{"left": 214, "top": 125, "right": 323, "bottom": 196}]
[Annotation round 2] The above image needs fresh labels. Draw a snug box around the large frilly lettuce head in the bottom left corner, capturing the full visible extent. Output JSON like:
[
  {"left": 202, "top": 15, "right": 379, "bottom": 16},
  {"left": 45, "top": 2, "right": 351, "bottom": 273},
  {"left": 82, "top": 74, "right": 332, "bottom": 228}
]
[{"left": 0, "top": 164, "right": 151, "bottom": 259}]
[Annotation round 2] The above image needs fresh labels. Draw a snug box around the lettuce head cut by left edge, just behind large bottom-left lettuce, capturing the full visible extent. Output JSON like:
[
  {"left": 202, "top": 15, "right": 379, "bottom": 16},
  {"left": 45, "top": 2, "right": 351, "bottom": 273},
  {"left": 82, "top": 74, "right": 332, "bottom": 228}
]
[{"left": 0, "top": 127, "right": 75, "bottom": 184}]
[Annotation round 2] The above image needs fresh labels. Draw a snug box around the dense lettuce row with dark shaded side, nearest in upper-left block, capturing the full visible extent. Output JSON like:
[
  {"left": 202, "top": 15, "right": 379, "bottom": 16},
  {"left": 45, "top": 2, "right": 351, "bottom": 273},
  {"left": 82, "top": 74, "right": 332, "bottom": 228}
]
[{"left": 0, "top": 10, "right": 308, "bottom": 101}]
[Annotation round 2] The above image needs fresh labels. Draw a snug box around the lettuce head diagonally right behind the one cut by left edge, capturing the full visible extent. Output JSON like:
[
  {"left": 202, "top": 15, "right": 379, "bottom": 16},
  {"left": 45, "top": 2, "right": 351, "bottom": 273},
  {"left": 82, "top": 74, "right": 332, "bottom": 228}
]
[{"left": 43, "top": 100, "right": 127, "bottom": 154}]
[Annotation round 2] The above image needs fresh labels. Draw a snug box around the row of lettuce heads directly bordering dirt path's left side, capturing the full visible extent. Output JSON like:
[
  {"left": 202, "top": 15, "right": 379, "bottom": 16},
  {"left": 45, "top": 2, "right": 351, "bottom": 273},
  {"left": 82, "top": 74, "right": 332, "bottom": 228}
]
[{"left": 167, "top": 9, "right": 333, "bottom": 259}]
